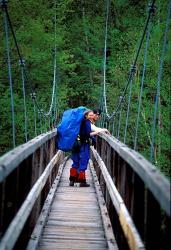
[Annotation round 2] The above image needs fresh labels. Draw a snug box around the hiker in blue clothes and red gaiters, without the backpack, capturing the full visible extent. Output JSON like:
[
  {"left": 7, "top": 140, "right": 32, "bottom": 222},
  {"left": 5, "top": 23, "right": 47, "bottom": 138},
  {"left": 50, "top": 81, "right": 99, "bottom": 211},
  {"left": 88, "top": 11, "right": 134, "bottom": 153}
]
[{"left": 69, "top": 110, "right": 99, "bottom": 187}]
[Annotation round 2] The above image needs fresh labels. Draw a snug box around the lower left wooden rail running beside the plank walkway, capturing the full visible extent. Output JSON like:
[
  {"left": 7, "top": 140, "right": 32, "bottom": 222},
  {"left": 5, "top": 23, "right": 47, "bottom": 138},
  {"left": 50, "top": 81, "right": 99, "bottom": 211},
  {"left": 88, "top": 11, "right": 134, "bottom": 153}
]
[{"left": 0, "top": 150, "right": 63, "bottom": 250}]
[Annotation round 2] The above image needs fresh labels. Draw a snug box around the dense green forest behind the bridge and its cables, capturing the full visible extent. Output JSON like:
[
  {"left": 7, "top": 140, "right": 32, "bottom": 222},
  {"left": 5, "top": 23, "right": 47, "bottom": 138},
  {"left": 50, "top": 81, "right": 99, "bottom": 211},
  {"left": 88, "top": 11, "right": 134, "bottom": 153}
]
[{"left": 0, "top": 0, "right": 171, "bottom": 177}]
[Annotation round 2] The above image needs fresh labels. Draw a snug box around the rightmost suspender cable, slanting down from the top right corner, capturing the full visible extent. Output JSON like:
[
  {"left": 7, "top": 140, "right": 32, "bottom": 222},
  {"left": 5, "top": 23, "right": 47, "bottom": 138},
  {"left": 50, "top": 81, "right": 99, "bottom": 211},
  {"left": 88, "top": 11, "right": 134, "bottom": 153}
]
[{"left": 150, "top": 0, "right": 171, "bottom": 162}]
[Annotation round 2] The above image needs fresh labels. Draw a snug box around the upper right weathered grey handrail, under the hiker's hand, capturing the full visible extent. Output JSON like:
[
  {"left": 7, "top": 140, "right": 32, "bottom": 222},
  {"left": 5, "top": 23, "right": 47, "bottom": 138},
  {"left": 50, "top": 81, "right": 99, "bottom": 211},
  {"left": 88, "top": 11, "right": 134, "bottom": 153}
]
[{"left": 100, "top": 133, "right": 171, "bottom": 216}]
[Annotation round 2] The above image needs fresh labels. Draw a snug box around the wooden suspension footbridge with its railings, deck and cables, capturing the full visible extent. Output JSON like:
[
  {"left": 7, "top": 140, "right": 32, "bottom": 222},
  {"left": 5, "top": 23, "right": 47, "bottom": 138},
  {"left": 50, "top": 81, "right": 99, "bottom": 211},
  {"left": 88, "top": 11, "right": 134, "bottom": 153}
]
[{"left": 0, "top": 0, "right": 171, "bottom": 250}]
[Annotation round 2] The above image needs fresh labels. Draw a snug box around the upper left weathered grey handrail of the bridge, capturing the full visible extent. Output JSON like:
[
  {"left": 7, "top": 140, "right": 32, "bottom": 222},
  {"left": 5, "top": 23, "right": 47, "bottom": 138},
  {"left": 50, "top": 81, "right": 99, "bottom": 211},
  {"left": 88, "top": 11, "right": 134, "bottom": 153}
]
[{"left": 0, "top": 129, "right": 56, "bottom": 183}]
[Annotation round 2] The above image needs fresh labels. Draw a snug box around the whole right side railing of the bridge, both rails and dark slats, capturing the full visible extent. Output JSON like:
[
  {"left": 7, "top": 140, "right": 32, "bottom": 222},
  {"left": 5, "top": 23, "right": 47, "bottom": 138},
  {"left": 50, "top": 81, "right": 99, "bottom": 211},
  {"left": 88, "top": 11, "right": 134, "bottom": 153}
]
[{"left": 92, "top": 134, "right": 171, "bottom": 250}]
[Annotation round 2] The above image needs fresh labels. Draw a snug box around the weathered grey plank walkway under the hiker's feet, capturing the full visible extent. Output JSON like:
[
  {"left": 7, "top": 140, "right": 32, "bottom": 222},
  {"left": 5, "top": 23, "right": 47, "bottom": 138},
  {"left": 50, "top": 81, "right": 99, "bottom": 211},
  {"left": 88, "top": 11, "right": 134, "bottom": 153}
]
[{"left": 38, "top": 160, "right": 118, "bottom": 250}]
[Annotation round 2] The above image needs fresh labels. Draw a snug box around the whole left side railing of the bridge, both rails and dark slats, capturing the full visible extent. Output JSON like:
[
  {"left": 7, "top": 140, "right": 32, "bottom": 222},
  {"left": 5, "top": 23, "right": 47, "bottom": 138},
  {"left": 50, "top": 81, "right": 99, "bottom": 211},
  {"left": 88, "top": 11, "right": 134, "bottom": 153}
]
[{"left": 0, "top": 130, "right": 64, "bottom": 250}]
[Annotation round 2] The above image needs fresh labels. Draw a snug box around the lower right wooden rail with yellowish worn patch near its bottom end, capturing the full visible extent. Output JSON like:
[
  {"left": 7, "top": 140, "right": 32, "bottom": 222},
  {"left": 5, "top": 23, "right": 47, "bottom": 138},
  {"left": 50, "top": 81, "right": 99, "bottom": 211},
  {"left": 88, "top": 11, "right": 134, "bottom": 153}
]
[{"left": 91, "top": 147, "right": 145, "bottom": 250}]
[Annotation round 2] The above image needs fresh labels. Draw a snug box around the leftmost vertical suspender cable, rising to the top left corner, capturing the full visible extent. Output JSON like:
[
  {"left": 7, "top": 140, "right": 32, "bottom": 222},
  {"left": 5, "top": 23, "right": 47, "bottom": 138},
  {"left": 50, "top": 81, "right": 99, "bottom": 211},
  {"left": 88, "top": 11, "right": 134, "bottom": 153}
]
[{"left": 2, "top": 1, "right": 16, "bottom": 148}]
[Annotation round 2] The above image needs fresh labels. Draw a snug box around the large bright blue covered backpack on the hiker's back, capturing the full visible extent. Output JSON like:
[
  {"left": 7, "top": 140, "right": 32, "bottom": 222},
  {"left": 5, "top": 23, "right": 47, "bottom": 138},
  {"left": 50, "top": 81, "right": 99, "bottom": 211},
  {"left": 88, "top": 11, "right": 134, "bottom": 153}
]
[{"left": 56, "top": 107, "right": 86, "bottom": 152}]
